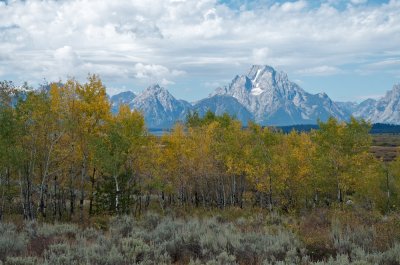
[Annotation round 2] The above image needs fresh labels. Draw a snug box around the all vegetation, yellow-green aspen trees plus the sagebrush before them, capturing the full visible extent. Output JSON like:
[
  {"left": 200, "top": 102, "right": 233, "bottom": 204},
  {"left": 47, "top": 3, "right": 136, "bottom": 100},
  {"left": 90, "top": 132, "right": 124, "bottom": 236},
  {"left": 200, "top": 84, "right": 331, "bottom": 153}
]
[{"left": 0, "top": 75, "right": 400, "bottom": 264}]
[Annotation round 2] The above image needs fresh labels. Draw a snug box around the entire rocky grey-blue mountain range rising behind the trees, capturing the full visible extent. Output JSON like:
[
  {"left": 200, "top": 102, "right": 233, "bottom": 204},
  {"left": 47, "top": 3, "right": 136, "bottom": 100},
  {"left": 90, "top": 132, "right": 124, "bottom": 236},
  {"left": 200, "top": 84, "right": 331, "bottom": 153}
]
[{"left": 111, "top": 65, "right": 400, "bottom": 129}]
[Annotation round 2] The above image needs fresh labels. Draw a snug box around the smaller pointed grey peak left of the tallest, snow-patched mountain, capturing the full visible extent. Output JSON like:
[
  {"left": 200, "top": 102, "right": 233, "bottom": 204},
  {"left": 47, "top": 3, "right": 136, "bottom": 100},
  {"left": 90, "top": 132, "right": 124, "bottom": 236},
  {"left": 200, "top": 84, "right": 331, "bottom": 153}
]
[{"left": 130, "top": 85, "right": 192, "bottom": 128}]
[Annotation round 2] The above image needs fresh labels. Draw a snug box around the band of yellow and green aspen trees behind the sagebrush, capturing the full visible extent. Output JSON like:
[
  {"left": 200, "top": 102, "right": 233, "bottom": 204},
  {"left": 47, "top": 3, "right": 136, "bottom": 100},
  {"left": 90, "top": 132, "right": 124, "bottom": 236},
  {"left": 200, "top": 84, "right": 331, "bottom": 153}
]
[{"left": 0, "top": 75, "right": 400, "bottom": 220}]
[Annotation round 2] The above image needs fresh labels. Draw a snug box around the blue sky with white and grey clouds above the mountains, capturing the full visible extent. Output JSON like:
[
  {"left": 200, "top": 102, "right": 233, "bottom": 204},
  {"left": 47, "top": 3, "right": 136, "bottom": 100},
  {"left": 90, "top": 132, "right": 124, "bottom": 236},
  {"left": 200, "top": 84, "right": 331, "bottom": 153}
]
[{"left": 0, "top": 0, "right": 400, "bottom": 102}]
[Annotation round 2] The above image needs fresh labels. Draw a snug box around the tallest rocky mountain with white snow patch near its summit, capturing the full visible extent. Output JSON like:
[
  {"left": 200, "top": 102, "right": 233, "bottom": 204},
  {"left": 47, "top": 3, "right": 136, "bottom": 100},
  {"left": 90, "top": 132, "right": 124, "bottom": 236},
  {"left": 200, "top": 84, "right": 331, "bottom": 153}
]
[{"left": 215, "top": 65, "right": 348, "bottom": 126}]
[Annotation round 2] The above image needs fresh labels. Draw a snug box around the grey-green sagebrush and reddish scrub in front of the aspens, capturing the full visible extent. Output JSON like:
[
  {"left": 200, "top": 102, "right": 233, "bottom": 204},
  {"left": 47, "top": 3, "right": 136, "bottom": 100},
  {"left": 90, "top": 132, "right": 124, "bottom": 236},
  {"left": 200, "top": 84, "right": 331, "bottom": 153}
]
[{"left": 0, "top": 209, "right": 400, "bottom": 265}]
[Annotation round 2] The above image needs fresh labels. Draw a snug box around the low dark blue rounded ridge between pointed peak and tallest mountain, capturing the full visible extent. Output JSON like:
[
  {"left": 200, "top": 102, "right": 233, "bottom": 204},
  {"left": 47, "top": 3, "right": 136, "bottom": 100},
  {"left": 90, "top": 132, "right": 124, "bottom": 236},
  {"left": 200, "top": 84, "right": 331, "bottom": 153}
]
[{"left": 193, "top": 95, "right": 254, "bottom": 125}]
